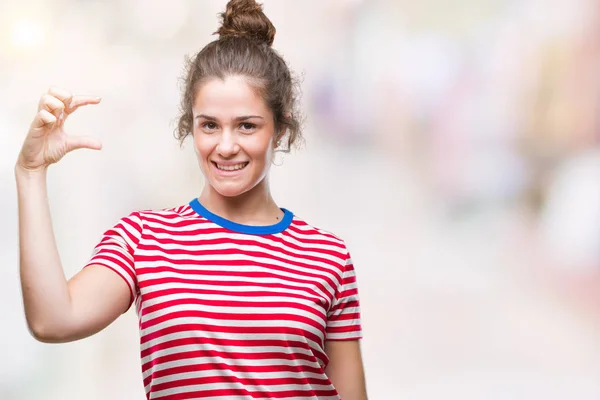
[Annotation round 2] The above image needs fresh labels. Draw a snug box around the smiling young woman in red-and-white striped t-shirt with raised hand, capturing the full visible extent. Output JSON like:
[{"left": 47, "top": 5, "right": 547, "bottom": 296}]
[{"left": 15, "top": 0, "right": 367, "bottom": 400}]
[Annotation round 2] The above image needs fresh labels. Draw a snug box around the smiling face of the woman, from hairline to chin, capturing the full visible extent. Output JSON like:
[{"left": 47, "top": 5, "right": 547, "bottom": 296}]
[{"left": 192, "top": 76, "right": 275, "bottom": 197}]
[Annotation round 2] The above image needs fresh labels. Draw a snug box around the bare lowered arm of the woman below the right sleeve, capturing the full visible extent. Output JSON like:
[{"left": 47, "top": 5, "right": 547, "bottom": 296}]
[{"left": 325, "top": 340, "right": 367, "bottom": 400}]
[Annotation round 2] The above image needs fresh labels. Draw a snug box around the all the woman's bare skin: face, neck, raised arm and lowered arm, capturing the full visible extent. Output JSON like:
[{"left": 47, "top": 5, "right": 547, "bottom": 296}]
[{"left": 15, "top": 76, "right": 367, "bottom": 400}]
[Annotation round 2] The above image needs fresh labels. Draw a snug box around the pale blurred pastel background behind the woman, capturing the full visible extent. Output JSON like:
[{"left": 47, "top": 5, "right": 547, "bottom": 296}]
[{"left": 0, "top": 0, "right": 600, "bottom": 400}]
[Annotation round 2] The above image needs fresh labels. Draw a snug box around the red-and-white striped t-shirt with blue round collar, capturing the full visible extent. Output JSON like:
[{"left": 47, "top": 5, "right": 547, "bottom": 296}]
[{"left": 87, "top": 199, "right": 362, "bottom": 400}]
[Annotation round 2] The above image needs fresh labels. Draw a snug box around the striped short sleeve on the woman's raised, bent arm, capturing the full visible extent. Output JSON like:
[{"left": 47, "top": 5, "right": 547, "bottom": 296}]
[{"left": 84, "top": 213, "right": 142, "bottom": 310}]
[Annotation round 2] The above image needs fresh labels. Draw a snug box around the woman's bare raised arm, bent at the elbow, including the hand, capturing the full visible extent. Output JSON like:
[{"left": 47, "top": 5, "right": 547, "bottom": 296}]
[{"left": 15, "top": 89, "right": 130, "bottom": 342}]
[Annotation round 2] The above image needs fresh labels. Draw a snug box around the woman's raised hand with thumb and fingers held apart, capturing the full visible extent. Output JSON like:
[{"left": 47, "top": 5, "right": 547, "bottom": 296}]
[{"left": 17, "top": 87, "right": 102, "bottom": 171}]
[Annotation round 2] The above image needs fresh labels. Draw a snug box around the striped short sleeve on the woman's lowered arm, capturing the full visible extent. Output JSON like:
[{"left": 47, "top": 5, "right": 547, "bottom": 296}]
[{"left": 326, "top": 253, "right": 362, "bottom": 340}]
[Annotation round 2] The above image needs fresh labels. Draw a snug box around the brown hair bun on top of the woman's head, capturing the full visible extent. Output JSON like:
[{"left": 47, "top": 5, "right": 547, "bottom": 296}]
[{"left": 215, "top": 0, "right": 275, "bottom": 46}]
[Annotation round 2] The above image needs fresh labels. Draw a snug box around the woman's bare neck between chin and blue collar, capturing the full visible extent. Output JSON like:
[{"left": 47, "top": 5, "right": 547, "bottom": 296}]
[{"left": 198, "top": 181, "right": 283, "bottom": 225}]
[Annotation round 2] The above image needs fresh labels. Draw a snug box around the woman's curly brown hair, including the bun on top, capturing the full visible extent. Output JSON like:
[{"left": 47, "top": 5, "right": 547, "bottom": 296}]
[{"left": 175, "top": 0, "right": 302, "bottom": 152}]
